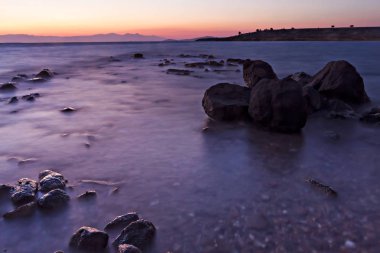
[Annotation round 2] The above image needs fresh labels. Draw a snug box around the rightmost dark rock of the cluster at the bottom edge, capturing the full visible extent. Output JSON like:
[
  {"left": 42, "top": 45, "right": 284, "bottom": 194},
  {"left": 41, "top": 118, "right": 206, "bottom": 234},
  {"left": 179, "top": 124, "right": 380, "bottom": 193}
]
[{"left": 113, "top": 220, "right": 156, "bottom": 249}]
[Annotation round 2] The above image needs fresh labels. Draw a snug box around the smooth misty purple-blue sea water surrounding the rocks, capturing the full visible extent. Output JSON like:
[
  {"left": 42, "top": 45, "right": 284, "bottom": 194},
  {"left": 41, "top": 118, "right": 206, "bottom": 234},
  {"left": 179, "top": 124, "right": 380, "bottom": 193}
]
[{"left": 0, "top": 42, "right": 380, "bottom": 253}]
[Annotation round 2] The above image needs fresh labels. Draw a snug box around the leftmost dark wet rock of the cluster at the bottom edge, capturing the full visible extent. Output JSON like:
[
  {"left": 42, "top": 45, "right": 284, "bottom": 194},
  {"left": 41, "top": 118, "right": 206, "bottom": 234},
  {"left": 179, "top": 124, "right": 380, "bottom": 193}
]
[{"left": 70, "top": 227, "right": 108, "bottom": 251}]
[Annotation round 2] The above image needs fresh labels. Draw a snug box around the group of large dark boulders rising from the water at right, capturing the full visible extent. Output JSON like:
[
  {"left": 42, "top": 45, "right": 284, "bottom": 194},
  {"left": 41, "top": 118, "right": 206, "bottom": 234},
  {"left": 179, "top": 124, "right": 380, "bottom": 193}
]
[{"left": 202, "top": 59, "right": 380, "bottom": 132}]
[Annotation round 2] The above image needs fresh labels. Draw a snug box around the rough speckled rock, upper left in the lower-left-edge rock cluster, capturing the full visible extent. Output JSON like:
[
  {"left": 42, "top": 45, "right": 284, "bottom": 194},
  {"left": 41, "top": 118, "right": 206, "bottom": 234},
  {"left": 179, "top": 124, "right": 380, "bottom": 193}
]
[{"left": 11, "top": 178, "right": 38, "bottom": 205}]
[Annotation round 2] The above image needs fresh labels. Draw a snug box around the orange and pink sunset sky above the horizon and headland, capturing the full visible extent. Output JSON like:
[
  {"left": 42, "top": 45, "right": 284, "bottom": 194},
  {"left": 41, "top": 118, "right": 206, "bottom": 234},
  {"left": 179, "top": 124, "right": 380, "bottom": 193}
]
[{"left": 0, "top": 0, "right": 380, "bottom": 39}]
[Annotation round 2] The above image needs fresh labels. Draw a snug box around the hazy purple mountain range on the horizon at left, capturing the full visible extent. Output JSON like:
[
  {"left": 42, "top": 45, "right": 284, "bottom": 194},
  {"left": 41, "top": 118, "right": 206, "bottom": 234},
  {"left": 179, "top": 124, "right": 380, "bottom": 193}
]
[{"left": 0, "top": 33, "right": 166, "bottom": 43}]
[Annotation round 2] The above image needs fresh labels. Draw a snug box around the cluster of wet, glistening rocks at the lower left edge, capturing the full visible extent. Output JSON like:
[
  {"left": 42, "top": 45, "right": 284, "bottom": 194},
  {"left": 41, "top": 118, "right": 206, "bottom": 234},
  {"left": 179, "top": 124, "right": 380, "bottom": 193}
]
[{"left": 0, "top": 170, "right": 70, "bottom": 219}]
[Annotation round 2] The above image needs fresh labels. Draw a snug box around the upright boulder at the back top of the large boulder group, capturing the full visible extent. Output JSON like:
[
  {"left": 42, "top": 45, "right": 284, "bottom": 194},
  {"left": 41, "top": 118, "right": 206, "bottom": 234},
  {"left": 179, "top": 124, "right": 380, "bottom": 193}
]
[{"left": 243, "top": 60, "right": 278, "bottom": 88}]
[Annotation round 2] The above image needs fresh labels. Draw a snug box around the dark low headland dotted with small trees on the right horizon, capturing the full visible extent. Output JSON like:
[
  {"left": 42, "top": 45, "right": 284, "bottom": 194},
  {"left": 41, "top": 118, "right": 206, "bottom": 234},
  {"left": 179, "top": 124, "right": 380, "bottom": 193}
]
[{"left": 197, "top": 27, "right": 380, "bottom": 41}]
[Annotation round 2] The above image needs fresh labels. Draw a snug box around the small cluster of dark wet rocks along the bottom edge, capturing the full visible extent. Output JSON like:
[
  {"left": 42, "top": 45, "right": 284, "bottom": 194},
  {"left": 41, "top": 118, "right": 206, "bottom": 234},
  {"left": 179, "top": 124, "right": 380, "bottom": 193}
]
[{"left": 70, "top": 213, "right": 156, "bottom": 253}]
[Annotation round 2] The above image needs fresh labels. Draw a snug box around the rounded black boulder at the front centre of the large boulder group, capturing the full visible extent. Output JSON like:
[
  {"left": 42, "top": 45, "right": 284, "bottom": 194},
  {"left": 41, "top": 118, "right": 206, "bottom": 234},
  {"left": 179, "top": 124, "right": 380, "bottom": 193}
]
[{"left": 249, "top": 78, "right": 307, "bottom": 133}]
